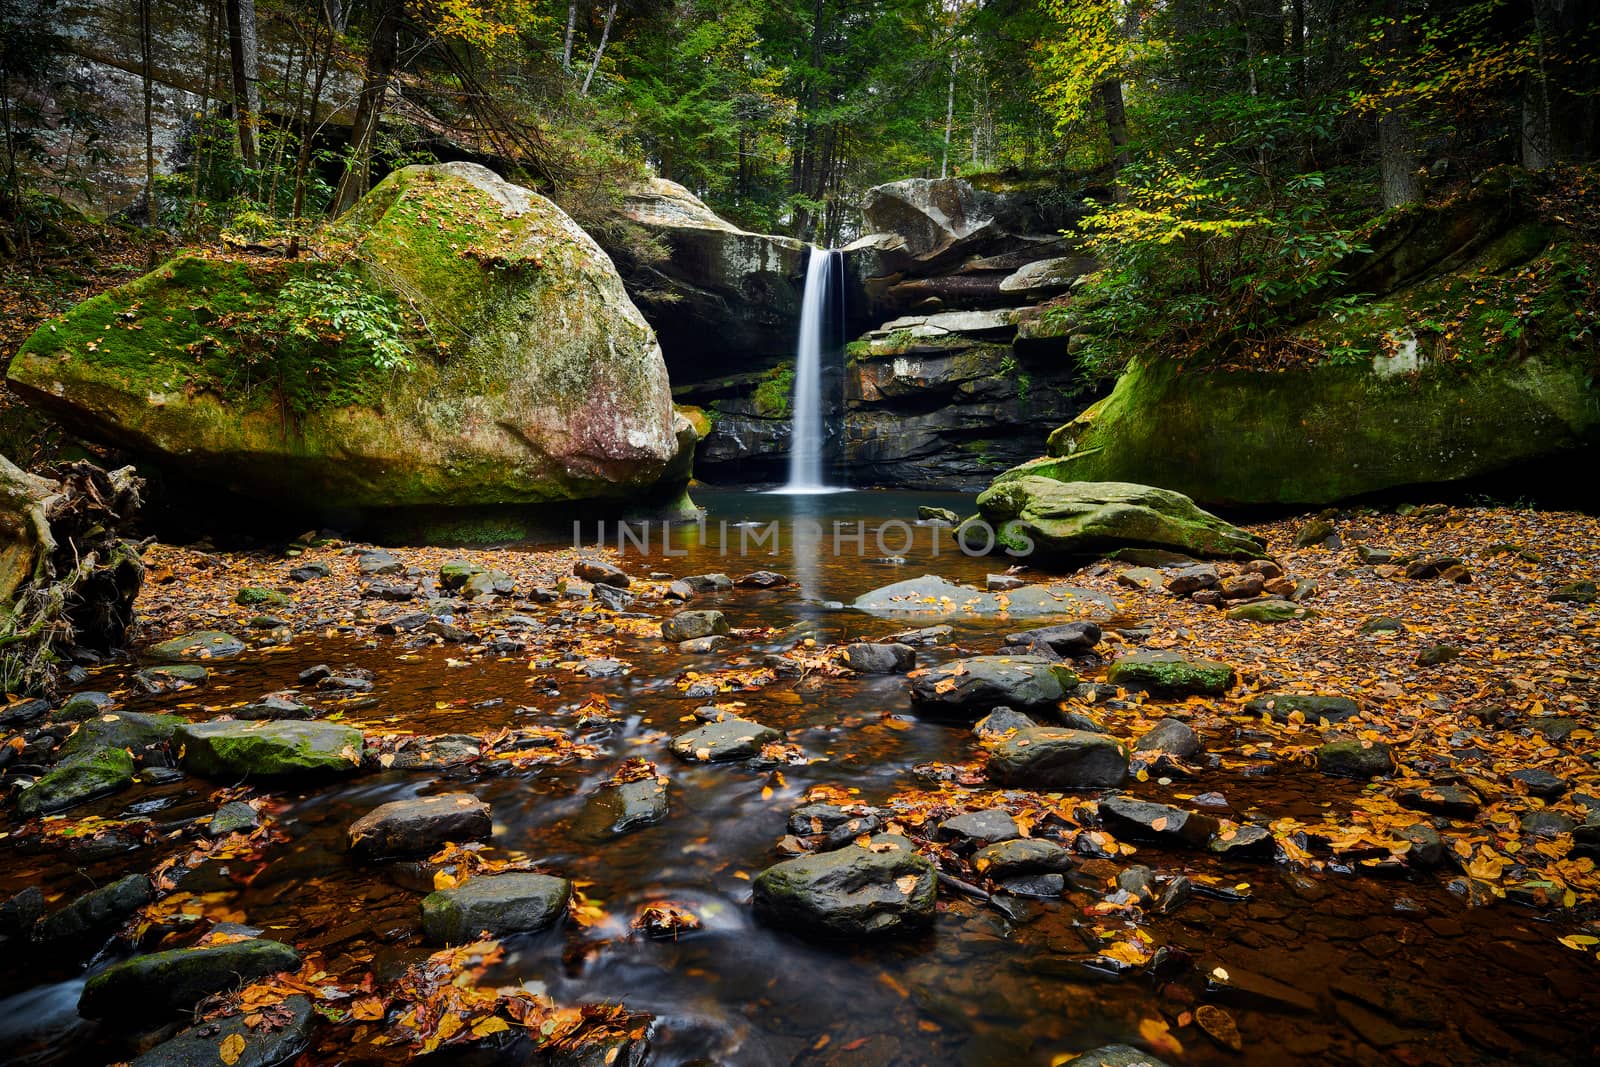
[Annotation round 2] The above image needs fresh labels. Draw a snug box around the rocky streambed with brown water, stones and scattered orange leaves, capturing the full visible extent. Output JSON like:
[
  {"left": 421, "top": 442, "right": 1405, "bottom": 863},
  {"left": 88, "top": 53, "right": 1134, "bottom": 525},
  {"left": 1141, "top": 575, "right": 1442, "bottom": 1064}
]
[{"left": 0, "top": 494, "right": 1600, "bottom": 1064}]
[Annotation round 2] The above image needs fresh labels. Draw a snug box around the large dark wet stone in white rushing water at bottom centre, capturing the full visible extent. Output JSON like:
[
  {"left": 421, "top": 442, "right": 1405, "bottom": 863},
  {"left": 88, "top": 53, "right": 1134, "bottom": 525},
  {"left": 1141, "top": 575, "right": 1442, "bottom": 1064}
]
[{"left": 754, "top": 833, "right": 938, "bottom": 937}]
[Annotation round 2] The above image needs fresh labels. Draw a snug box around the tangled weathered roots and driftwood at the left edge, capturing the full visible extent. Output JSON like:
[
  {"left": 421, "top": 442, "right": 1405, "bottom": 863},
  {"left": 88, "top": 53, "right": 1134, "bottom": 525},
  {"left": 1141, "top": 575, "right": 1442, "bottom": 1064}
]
[{"left": 0, "top": 456, "right": 144, "bottom": 694}]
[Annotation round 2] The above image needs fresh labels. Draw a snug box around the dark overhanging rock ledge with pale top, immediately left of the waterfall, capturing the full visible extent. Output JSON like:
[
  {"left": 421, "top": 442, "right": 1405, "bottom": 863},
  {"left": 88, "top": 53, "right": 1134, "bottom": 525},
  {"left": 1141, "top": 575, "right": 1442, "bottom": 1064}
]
[{"left": 619, "top": 178, "right": 806, "bottom": 379}]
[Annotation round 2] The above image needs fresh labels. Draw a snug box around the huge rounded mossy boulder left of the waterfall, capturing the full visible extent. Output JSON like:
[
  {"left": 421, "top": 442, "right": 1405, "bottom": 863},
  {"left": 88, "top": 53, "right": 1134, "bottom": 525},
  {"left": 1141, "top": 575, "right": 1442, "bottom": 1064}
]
[{"left": 11, "top": 163, "right": 693, "bottom": 509}]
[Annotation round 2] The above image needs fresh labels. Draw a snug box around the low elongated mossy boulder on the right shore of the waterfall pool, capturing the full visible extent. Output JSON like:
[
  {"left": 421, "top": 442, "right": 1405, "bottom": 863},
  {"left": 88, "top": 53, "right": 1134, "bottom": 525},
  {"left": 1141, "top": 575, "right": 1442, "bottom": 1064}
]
[{"left": 978, "top": 469, "right": 1262, "bottom": 560}]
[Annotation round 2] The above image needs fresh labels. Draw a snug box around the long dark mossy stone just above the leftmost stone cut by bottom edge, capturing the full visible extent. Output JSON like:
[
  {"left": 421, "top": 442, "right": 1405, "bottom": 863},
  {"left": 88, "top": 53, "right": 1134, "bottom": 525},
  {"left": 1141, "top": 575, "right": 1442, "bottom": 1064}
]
[{"left": 78, "top": 937, "right": 301, "bottom": 1022}]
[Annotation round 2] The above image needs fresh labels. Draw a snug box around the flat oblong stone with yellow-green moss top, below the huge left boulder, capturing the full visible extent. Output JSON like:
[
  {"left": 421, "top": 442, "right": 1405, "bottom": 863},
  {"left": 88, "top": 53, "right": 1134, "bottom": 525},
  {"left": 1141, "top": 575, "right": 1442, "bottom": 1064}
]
[{"left": 173, "top": 721, "right": 362, "bottom": 779}]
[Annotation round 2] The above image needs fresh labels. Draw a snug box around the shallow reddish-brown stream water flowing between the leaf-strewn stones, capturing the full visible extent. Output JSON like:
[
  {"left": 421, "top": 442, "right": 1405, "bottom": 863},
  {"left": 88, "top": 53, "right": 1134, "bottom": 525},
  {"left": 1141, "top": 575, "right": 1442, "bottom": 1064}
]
[{"left": 0, "top": 491, "right": 1595, "bottom": 1067}]
